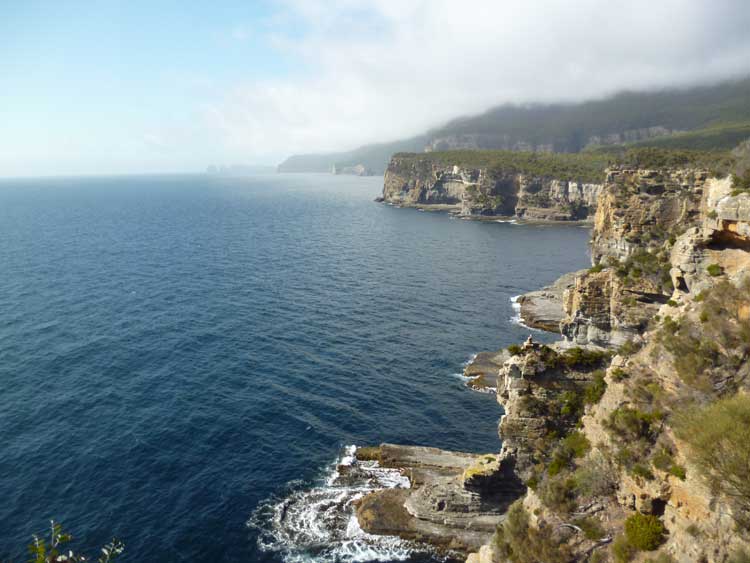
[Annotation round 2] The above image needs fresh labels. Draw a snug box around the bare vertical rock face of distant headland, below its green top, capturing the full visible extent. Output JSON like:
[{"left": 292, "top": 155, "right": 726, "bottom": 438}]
[{"left": 382, "top": 156, "right": 602, "bottom": 221}]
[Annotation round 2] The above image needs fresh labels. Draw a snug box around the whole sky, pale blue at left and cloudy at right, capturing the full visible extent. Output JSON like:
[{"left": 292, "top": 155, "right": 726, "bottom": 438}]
[{"left": 0, "top": 0, "right": 750, "bottom": 176}]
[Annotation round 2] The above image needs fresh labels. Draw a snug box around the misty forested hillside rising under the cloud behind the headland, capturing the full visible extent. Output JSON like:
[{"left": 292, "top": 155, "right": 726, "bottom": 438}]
[{"left": 279, "top": 78, "right": 750, "bottom": 174}]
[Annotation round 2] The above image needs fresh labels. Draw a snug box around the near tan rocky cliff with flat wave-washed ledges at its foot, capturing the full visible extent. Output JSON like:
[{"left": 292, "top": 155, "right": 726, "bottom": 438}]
[{"left": 350, "top": 160, "right": 750, "bottom": 563}]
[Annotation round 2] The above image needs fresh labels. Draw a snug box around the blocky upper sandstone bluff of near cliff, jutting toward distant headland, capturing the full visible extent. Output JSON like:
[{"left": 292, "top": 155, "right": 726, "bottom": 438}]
[{"left": 560, "top": 167, "right": 716, "bottom": 346}]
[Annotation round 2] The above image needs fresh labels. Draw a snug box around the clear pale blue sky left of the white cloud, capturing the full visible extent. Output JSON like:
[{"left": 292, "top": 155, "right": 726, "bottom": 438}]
[{"left": 0, "top": 1, "right": 294, "bottom": 173}]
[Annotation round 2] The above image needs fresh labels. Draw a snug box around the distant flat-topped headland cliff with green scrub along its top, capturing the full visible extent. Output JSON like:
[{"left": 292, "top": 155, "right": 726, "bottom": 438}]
[{"left": 381, "top": 152, "right": 603, "bottom": 221}]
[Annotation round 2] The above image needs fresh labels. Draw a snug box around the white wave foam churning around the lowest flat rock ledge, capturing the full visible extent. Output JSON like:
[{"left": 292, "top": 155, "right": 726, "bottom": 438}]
[{"left": 247, "top": 446, "right": 430, "bottom": 563}]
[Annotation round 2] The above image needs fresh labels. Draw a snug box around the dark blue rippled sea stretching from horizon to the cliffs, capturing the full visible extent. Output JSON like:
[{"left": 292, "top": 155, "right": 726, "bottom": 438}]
[{"left": 0, "top": 175, "right": 589, "bottom": 563}]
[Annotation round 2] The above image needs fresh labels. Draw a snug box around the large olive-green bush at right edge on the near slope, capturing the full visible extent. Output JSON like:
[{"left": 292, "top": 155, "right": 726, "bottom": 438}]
[{"left": 675, "top": 394, "right": 750, "bottom": 527}]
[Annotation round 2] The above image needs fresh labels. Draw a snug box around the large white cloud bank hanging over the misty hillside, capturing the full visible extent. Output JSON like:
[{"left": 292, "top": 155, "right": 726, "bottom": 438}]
[{"left": 204, "top": 0, "right": 750, "bottom": 161}]
